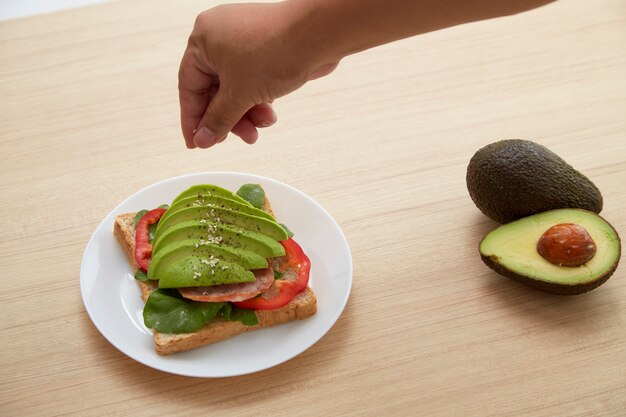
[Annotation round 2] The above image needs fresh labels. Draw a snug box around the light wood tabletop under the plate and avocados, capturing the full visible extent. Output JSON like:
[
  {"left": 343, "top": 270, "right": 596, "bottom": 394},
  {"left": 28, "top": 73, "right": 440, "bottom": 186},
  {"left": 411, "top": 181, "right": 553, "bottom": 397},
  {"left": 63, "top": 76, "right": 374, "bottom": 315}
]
[{"left": 0, "top": 0, "right": 626, "bottom": 416}]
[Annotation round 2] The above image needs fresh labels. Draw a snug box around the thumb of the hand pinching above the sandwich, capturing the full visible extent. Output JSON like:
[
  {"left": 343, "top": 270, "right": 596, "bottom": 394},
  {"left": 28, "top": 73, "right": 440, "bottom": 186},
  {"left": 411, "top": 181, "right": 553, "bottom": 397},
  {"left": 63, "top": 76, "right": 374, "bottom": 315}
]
[{"left": 193, "top": 88, "right": 248, "bottom": 148}]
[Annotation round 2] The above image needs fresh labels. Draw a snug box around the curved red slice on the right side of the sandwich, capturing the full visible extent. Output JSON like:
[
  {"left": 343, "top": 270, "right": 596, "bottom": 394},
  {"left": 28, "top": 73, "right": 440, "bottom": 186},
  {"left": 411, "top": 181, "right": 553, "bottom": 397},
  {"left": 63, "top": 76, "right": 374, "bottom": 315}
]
[{"left": 233, "top": 238, "right": 311, "bottom": 310}]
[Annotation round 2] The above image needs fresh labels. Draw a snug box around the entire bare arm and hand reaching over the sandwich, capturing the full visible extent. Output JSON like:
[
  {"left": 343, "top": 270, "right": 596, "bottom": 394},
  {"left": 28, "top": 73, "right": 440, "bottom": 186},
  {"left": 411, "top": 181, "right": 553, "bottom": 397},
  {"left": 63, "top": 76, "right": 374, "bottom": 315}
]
[{"left": 179, "top": 0, "right": 551, "bottom": 148}]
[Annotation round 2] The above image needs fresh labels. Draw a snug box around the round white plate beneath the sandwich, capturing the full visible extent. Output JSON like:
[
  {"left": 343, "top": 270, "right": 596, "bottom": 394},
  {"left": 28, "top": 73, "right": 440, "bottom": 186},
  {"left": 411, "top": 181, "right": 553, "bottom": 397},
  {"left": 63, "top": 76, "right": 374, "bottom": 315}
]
[{"left": 80, "top": 172, "right": 352, "bottom": 377}]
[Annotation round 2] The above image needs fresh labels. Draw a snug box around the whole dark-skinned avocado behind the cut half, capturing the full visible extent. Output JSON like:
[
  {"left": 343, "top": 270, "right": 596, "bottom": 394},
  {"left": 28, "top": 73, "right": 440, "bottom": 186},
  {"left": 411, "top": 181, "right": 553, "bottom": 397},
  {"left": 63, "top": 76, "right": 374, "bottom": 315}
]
[{"left": 466, "top": 139, "right": 602, "bottom": 223}]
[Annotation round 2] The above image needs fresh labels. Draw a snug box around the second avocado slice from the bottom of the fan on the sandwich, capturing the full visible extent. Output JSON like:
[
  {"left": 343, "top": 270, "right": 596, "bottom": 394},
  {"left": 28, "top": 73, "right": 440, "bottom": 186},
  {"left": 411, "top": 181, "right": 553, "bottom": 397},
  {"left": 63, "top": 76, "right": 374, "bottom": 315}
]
[{"left": 148, "top": 239, "right": 268, "bottom": 279}]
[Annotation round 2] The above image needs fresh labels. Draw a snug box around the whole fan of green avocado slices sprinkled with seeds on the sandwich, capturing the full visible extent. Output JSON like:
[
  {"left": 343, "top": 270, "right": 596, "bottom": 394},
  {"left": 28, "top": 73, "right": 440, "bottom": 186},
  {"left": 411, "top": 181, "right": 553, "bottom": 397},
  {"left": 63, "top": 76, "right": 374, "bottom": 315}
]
[{"left": 148, "top": 184, "right": 288, "bottom": 288}]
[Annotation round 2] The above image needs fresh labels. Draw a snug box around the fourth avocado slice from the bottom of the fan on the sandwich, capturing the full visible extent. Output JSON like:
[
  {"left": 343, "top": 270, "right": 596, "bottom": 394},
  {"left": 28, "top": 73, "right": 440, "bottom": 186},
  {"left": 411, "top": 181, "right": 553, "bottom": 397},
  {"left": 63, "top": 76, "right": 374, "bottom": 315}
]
[{"left": 154, "top": 207, "right": 287, "bottom": 241}]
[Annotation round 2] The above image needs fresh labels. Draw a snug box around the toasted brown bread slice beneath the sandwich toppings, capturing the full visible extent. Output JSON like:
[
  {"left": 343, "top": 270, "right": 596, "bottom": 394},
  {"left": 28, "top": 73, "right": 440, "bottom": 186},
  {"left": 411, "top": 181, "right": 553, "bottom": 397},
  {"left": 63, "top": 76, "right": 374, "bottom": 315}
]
[{"left": 113, "top": 198, "right": 317, "bottom": 355}]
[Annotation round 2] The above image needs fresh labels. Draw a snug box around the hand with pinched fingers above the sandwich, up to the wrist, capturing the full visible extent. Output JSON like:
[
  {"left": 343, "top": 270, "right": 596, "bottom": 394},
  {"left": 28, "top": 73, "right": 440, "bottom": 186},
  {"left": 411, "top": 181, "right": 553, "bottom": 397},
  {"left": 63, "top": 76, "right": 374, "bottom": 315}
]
[{"left": 178, "top": 3, "right": 338, "bottom": 148}]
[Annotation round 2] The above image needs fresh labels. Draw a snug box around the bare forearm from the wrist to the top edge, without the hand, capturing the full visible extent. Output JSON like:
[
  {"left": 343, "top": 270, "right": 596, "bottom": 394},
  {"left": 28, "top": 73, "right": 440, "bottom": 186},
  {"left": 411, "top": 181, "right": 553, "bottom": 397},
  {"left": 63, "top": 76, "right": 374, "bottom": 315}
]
[{"left": 283, "top": 0, "right": 553, "bottom": 60}]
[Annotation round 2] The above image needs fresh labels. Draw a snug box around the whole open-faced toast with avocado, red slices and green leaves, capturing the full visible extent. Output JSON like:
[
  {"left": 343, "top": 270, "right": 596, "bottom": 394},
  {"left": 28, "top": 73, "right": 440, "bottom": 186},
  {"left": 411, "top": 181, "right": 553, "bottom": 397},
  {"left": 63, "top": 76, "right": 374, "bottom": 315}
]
[{"left": 114, "top": 184, "right": 317, "bottom": 355}]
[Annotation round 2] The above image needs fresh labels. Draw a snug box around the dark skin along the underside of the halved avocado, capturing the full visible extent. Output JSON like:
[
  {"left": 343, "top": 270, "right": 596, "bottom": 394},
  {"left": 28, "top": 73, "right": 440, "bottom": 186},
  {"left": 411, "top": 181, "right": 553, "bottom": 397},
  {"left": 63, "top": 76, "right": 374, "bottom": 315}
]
[{"left": 480, "top": 251, "right": 621, "bottom": 295}]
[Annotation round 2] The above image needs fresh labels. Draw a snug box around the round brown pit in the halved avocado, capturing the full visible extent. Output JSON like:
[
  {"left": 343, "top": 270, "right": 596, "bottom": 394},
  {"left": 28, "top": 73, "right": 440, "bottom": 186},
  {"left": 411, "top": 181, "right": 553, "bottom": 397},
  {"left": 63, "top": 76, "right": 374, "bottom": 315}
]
[{"left": 537, "top": 223, "right": 596, "bottom": 268}]
